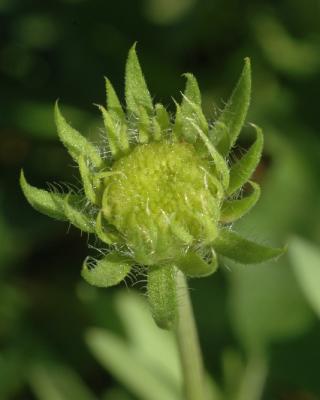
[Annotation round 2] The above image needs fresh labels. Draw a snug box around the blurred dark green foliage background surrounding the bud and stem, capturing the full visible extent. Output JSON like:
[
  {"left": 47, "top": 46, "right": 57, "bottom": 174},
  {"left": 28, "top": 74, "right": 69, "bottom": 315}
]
[{"left": 0, "top": 0, "right": 320, "bottom": 400}]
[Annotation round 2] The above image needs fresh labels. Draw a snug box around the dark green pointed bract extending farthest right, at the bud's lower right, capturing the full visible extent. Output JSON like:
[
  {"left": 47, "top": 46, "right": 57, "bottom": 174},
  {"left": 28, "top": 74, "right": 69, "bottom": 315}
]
[{"left": 213, "top": 229, "right": 286, "bottom": 264}]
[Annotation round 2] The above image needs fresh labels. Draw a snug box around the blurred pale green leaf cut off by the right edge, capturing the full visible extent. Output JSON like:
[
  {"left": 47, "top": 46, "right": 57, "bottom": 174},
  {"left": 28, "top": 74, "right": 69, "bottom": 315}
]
[{"left": 289, "top": 237, "right": 320, "bottom": 317}]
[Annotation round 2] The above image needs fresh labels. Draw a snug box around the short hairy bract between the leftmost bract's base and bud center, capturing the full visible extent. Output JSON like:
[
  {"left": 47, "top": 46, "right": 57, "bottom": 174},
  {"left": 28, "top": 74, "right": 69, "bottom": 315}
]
[{"left": 63, "top": 195, "right": 95, "bottom": 233}]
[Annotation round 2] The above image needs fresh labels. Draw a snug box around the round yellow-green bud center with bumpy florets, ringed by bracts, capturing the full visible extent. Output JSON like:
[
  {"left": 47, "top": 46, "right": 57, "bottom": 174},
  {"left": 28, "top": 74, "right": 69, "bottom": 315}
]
[{"left": 102, "top": 142, "right": 220, "bottom": 264}]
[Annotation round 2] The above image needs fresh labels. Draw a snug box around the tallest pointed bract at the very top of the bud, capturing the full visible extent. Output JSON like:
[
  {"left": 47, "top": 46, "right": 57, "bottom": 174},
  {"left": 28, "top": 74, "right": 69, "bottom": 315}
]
[{"left": 125, "top": 44, "right": 153, "bottom": 116}]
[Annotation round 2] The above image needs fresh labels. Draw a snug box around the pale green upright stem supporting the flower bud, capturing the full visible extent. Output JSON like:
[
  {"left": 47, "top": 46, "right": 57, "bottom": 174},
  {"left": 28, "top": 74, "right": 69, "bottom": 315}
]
[{"left": 176, "top": 271, "right": 205, "bottom": 400}]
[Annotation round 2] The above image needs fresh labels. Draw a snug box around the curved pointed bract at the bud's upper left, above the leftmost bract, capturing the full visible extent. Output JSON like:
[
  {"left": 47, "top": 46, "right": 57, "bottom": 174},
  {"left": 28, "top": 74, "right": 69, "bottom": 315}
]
[{"left": 54, "top": 102, "right": 103, "bottom": 168}]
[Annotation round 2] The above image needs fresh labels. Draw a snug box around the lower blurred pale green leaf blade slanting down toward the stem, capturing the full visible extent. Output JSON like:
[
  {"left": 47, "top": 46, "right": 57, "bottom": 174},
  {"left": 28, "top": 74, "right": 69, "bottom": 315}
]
[{"left": 86, "top": 328, "right": 179, "bottom": 400}]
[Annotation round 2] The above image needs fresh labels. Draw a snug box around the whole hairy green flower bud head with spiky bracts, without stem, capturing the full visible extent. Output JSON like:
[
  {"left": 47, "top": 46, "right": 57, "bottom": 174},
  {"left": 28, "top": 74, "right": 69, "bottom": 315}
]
[{"left": 20, "top": 46, "right": 283, "bottom": 328}]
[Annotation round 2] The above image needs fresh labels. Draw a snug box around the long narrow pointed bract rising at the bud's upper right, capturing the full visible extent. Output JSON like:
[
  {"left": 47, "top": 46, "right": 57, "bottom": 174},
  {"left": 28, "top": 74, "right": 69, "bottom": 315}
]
[{"left": 211, "top": 58, "right": 251, "bottom": 156}]
